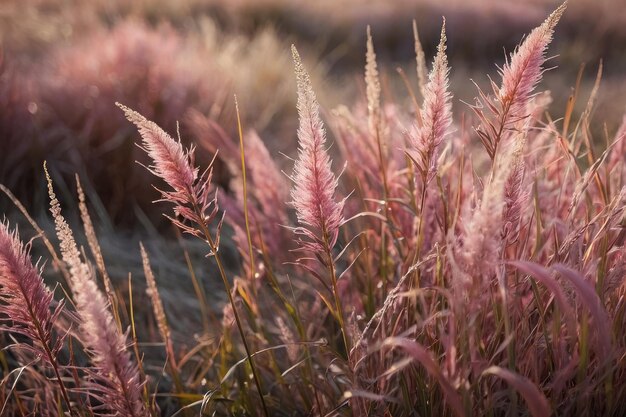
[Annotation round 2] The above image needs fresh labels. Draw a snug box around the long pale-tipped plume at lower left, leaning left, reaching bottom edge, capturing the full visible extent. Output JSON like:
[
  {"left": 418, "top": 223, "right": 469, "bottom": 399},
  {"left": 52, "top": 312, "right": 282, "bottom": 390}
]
[{"left": 44, "top": 166, "right": 146, "bottom": 417}]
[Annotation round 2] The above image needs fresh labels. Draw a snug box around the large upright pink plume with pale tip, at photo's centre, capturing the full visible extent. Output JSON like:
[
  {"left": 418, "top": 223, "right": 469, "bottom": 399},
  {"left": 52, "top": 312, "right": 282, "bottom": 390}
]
[{"left": 291, "top": 45, "right": 344, "bottom": 251}]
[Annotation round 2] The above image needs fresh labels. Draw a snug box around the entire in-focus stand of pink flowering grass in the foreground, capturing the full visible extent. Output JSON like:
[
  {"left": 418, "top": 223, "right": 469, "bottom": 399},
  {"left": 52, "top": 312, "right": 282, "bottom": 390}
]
[{"left": 0, "top": 1, "right": 626, "bottom": 417}]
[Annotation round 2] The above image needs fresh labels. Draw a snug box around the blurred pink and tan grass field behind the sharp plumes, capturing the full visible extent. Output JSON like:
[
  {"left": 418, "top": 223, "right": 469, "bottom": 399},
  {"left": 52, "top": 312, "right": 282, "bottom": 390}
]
[{"left": 0, "top": 0, "right": 626, "bottom": 328}]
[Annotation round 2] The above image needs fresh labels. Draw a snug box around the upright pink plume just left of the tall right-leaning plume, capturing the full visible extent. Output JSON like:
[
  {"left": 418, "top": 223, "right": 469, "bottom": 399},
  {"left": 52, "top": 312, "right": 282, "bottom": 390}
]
[{"left": 411, "top": 20, "right": 452, "bottom": 182}]
